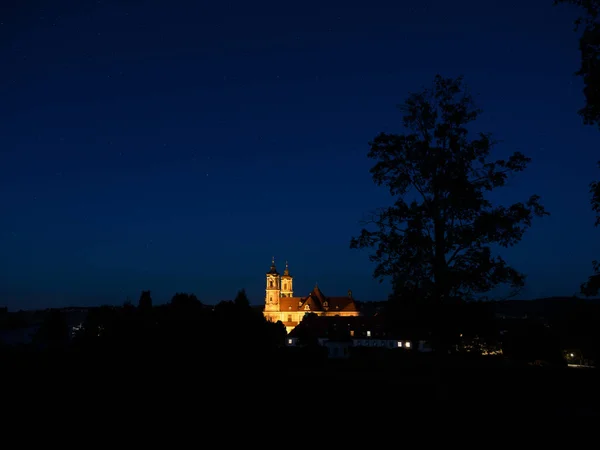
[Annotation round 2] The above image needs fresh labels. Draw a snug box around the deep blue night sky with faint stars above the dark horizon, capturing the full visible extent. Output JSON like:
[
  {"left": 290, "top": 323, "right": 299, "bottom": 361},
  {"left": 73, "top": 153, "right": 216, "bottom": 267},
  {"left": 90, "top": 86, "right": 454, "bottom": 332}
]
[{"left": 0, "top": 0, "right": 600, "bottom": 309}]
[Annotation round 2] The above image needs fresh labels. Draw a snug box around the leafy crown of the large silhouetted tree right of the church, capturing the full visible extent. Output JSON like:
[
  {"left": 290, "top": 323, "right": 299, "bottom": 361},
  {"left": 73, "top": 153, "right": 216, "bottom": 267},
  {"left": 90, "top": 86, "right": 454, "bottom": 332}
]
[{"left": 350, "top": 75, "right": 547, "bottom": 301}]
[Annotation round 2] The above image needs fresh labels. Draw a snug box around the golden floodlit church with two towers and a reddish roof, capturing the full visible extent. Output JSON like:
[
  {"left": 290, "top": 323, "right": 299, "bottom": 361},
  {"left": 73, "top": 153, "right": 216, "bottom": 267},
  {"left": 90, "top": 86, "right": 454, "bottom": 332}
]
[{"left": 264, "top": 258, "right": 360, "bottom": 333}]
